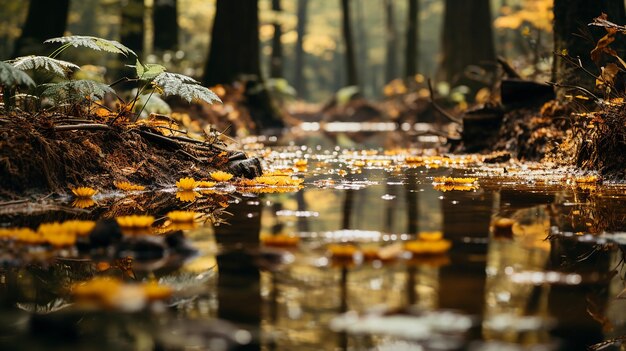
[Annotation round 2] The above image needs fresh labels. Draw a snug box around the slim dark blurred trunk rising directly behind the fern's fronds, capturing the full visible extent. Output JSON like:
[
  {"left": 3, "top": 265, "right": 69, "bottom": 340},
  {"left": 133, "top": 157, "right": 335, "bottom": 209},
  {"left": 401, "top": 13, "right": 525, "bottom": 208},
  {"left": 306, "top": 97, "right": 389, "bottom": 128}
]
[{"left": 120, "top": 0, "right": 144, "bottom": 58}]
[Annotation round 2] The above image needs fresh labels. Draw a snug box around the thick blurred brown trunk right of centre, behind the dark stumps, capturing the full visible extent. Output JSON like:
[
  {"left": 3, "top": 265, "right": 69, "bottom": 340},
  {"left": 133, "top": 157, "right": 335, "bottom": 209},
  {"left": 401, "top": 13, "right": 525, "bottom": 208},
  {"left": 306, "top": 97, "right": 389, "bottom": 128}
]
[{"left": 438, "top": 0, "right": 496, "bottom": 89}]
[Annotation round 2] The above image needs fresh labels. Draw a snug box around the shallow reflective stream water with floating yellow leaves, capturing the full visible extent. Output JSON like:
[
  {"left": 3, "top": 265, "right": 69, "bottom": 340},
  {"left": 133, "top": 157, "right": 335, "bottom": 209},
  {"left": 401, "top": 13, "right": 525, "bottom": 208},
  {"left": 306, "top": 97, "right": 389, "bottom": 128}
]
[{"left": 0, "top": 130, "right": 626, "bottom": 350}]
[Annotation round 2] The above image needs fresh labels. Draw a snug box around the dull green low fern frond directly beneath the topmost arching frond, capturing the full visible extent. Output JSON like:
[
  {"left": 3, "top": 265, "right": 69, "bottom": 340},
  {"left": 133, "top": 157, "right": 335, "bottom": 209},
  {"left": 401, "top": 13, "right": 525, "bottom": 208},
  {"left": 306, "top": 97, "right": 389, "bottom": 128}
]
[{"left": 41, "top": 79, "right": 115, "bottom": 101}]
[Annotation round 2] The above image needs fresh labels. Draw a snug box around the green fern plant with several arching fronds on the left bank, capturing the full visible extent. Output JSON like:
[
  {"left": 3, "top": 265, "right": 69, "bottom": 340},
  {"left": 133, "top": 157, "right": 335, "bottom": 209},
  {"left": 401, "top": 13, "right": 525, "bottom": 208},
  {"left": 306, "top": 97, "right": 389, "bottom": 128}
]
[{"left": 0, "top": 35, "right": 221, "bottom": 119}]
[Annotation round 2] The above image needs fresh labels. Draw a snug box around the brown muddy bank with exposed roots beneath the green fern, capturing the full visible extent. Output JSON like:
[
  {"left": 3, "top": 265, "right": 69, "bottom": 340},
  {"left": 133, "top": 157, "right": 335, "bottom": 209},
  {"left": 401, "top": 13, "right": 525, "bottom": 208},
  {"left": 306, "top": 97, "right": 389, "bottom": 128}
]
[{"left": 0, "top": 113, "right": 261, "bottom": 199}]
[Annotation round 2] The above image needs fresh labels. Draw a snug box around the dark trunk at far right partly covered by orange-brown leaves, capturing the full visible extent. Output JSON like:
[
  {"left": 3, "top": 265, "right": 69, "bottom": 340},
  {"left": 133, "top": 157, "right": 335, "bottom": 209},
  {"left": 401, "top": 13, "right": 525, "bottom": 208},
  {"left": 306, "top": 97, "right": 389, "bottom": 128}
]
[{"left": 552, "top": 0, "right": 626, "bottom": 91}]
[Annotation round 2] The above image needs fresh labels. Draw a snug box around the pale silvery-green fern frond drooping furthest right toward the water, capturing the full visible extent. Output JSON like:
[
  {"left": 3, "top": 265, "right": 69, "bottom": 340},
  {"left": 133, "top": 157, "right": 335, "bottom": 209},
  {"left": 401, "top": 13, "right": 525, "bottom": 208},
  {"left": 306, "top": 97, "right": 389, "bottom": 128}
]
[{"left": 153, "top": 72, "right": 222, "bottom": 104}]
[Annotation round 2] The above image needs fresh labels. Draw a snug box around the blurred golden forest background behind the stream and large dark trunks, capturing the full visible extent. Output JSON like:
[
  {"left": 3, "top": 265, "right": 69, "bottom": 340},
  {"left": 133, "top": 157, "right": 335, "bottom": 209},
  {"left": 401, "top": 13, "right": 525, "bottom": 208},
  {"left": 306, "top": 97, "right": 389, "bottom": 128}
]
[{"left": 0, "top": 0, "right": 552, "bottom": 102}]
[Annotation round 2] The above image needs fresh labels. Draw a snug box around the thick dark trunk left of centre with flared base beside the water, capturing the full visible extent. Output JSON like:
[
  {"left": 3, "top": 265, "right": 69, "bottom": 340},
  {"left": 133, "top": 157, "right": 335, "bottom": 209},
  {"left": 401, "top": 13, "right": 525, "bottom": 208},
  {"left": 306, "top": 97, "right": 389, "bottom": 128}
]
[{"left": 202, "top": 0, "right": 283, "bottom": 131}]
